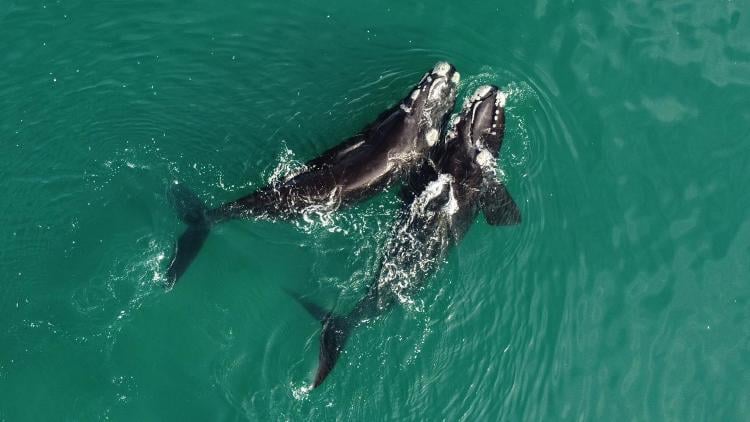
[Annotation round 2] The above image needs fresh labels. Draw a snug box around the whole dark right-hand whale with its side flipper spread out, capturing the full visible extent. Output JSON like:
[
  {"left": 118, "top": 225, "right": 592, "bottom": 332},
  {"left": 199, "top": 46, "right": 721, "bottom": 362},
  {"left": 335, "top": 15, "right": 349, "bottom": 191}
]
[{"left": 298, "top": 86, "right": 521, "bottom": 387}]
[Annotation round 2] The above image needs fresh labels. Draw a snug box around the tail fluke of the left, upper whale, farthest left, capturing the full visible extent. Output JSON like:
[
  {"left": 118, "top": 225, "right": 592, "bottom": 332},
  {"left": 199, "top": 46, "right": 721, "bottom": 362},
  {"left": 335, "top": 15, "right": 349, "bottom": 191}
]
[{"left": 166, "top": 184, "right": 211, "bottom": 287}]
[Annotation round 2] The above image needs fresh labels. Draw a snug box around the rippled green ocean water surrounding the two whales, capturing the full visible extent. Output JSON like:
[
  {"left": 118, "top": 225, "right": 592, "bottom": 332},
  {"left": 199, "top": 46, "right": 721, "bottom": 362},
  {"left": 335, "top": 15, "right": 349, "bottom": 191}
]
[{"left": 0, "top": 0, "right": 750, "bottom": 421}]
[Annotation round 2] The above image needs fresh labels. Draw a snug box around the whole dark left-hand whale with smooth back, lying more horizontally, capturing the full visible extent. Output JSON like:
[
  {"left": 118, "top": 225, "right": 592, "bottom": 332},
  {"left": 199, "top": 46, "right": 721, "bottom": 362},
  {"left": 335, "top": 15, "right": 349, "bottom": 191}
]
[{"left": 166, "top": 62, "right": 460, "bottom": 287}]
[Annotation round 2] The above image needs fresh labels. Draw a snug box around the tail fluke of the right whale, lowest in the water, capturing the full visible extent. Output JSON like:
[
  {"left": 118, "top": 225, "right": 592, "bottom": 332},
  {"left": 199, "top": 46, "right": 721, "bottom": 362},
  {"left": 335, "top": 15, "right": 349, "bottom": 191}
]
[{"left": 287, "top": 290, "right": 352, "bottom": 388}]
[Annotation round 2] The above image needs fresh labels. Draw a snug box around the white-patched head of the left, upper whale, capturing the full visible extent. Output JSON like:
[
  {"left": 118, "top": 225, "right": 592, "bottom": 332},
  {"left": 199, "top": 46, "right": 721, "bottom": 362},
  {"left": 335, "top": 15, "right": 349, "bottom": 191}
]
[{"left": 400, "top": 62, "right": 461, "bottom": 149}]
